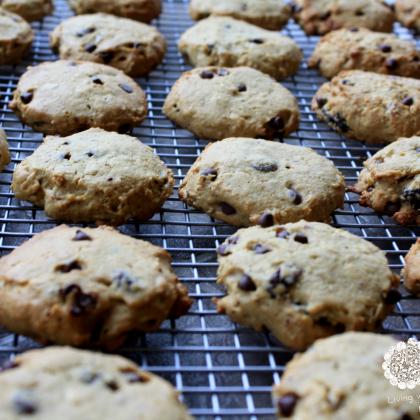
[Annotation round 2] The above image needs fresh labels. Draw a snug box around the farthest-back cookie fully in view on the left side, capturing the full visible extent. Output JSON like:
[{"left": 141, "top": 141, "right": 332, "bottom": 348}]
[{"left": 50, "top": 13, "right": 166, "bottom": 77}]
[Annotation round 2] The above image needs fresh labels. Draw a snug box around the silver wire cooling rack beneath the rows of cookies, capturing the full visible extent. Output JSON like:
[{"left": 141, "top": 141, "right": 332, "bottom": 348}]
[{"left": 0, "top": 0, "right": 420, "bottom": 419}]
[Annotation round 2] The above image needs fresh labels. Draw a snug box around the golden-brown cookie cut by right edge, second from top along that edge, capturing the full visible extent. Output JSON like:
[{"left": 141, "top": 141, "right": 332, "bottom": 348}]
[{"left": 309, "top": 28, "right": 420, "bottom": 79}]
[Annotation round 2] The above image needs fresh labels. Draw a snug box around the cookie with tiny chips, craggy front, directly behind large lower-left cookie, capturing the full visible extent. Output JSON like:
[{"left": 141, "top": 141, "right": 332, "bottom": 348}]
[{"left": 12, "top": 128, "right": 174, "bottom": 225}]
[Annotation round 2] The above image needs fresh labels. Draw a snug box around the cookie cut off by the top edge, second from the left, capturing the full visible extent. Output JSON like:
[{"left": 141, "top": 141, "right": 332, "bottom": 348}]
[{"left": 69, "top": 0, "right": 162, "bottom": 23}]
